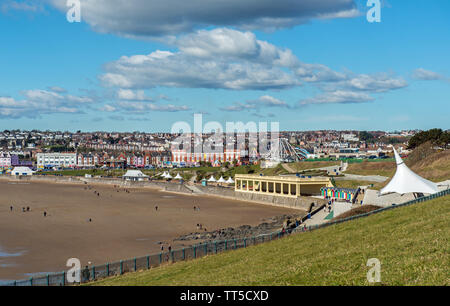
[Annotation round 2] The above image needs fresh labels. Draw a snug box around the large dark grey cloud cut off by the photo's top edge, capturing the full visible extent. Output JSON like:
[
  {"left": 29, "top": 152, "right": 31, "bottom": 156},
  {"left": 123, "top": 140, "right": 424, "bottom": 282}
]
[{"left": 46, "top": 0, "right": 359, "bottom": 37}]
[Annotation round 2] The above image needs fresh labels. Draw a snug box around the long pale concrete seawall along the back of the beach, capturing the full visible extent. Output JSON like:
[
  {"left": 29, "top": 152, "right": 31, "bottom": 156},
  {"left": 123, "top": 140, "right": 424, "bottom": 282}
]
[{"left": 0, "top": 175, "right": 326, "bottom": 210}]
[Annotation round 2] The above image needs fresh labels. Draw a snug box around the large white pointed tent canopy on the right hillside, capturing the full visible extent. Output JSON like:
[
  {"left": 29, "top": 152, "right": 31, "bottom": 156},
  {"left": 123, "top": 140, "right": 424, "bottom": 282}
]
[{"left": 380, "top": 148, "right": 439, "bottom": 194}]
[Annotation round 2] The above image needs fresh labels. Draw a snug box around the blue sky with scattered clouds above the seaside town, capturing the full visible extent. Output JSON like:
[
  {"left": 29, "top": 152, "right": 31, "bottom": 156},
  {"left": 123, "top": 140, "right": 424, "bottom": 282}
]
[{"left": 0, "top": 0, "right": 450, "bottom": 132}]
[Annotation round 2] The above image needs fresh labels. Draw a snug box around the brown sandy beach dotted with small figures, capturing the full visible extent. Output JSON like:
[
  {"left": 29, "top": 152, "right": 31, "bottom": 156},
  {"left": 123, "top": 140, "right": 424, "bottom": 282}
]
[{"left": 0, "top": 180, "right": 299, "bottom": 280}]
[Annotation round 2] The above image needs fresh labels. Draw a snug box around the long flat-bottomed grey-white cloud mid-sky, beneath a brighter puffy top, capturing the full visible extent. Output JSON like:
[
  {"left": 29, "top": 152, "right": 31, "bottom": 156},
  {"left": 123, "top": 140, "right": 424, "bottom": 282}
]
[{"left": 100, "top": 51, "right": 300, "bottom": 90}]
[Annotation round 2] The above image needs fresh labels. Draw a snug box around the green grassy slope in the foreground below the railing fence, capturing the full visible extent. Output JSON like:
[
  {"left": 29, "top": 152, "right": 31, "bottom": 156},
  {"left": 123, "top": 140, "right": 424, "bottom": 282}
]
[{"left": 89, "top": 196, "right": 450, "bottom": 286}]
